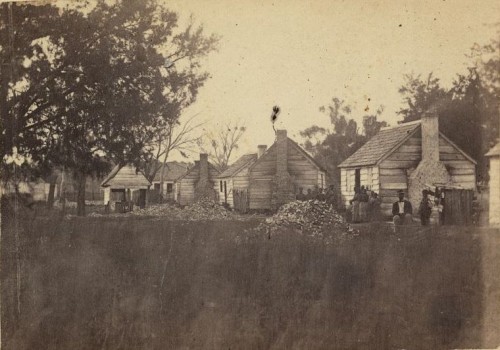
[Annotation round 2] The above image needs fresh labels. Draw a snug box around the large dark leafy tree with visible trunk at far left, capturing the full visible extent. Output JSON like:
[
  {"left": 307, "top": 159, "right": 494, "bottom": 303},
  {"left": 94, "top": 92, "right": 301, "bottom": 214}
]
[{"left": 2, "top": 0, "right": 217, "bottom": 215}]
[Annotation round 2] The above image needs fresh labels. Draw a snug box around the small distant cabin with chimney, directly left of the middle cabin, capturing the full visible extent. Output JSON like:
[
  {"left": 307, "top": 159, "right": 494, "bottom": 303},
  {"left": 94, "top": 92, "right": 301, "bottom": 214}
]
[{"left": 176, "top": 153, "right": 220, "bottom": 205}]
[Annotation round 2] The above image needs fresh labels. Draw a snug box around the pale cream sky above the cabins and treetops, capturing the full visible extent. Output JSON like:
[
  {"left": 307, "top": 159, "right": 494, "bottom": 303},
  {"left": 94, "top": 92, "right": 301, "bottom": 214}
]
[{"left": 167, "top": 0, "right": 500, "bottom": 160}]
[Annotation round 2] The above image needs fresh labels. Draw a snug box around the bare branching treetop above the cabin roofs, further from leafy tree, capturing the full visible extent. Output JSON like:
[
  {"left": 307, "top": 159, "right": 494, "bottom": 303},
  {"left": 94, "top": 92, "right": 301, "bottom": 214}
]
[{"left": 200, "top": 122, "right": 246, "bottom": 171}]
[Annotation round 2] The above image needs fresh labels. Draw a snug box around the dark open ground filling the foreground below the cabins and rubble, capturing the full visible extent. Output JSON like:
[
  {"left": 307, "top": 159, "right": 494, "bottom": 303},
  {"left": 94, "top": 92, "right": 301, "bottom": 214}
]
[{"left": 1, "top": 213, "right": 500, "bottom": 349}]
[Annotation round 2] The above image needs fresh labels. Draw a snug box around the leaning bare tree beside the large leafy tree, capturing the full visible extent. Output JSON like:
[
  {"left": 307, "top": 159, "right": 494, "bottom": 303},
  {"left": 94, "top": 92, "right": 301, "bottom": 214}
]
[{"left": 145, "top": 114, "right": 205, "bottom": 198}]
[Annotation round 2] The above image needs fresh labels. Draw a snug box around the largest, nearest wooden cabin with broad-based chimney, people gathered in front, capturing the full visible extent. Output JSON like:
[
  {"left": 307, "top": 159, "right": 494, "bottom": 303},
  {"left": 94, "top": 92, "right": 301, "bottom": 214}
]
[{"left": 339, "top": 111, "right": 476, "bottom": 216}]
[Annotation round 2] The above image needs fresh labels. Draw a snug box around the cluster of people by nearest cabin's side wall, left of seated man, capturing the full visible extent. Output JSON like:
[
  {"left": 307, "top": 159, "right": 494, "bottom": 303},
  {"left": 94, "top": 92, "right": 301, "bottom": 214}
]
[{"left": 350, "top": 186, "right": 382, "bottom": 223}]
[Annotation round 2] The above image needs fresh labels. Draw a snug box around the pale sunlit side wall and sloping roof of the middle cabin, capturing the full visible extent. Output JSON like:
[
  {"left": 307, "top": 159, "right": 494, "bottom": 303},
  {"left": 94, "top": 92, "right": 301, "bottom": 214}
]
[{"left": 216, "top": 152, "right": 258, "bottom": 209}]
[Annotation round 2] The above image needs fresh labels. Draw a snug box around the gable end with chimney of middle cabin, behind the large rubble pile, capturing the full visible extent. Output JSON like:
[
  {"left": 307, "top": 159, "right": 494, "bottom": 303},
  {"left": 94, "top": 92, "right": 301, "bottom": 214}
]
[{"left": 249, "top": 130, "right": 326, "bottom": 210}]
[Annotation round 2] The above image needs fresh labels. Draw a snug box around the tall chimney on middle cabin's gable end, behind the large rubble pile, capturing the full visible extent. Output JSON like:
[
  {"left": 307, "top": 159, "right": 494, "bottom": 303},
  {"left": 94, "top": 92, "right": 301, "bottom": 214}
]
[{"left": 271, "top": 130, "right": 295, "bottom": 210}]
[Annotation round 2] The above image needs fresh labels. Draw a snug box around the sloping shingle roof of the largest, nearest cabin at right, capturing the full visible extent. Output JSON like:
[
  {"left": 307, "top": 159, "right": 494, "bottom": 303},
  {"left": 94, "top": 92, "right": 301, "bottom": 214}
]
[{"left": 339, "top": 120, "right": 420, "bottom": 168}]
